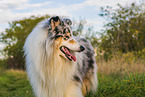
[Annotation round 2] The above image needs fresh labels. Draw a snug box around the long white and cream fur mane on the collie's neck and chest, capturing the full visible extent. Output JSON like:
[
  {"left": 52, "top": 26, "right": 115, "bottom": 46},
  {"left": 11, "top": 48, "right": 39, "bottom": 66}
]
[{"left": 24, "top": 22, "right": 76, "bottom": 97}]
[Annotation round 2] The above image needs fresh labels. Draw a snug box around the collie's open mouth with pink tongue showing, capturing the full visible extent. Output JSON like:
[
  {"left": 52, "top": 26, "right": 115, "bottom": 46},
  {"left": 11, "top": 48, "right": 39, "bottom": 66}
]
[{"left": 60, "top": 46, "right": 76, "bottom": 61}]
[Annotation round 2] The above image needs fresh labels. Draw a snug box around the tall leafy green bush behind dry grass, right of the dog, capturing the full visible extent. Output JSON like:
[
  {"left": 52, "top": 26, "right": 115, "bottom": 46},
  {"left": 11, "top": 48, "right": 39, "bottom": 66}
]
[{"left": 100, "top": 3, "right": 145, "bottom": 59}]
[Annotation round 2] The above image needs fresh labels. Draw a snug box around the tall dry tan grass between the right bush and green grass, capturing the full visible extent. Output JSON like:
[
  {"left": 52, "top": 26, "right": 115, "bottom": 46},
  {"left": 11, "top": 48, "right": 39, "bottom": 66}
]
[{"left": 97, "top": 54, "right": 145, "bottom": 75}]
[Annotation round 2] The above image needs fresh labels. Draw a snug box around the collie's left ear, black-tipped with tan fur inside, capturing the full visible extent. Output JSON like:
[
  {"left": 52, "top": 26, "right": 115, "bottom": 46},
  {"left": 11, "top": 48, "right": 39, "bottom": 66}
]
[{"left": 49, "top": 16, "right": 60, "bottom": 29}]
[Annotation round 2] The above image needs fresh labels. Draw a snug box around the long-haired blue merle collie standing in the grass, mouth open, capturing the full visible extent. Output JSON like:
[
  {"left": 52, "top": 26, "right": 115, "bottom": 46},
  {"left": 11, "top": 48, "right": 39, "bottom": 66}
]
[{"left": 24, "top": 16, "right": 97, "bottom": 97}]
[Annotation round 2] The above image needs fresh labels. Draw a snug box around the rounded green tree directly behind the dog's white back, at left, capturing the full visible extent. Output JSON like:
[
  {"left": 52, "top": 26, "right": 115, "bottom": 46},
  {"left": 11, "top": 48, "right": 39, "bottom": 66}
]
[{"left": 0, "top": 15, "right": 49, "bottom": 69}]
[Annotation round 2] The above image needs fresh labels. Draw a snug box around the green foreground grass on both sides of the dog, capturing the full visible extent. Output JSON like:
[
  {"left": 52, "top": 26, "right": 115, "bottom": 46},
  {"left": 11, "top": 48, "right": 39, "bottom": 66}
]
[{"left": 0, "top": 70, "right": 145, "bottom": 97}]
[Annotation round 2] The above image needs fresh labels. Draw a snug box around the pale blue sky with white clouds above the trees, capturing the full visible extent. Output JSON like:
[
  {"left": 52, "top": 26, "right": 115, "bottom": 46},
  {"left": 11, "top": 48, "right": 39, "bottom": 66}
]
[{"left": 0, "top": 0, "right": 142, "bottom": 57}]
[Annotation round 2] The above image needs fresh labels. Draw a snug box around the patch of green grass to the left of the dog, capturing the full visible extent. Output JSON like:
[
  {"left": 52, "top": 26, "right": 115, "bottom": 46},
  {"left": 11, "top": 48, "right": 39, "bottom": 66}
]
[{"left": 0, "top": 70, "right": 33, "bottom": 97}]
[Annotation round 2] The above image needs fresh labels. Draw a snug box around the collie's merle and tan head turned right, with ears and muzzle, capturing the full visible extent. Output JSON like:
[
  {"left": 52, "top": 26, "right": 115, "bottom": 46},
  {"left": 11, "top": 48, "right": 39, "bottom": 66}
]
[{"left": 49, "top": 16, "right": 85, "bottom": 61}]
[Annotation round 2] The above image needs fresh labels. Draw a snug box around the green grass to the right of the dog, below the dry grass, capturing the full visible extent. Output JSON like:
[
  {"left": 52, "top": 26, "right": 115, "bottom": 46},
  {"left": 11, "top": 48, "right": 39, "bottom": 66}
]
[{"left": 93, "top": 73, "right": 145, "bottom": 97}]
